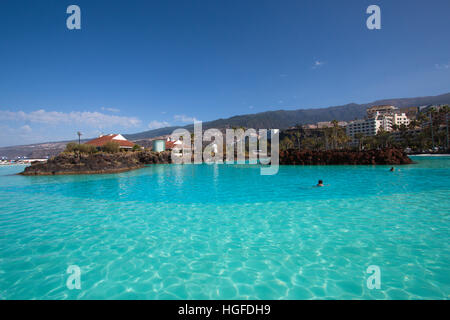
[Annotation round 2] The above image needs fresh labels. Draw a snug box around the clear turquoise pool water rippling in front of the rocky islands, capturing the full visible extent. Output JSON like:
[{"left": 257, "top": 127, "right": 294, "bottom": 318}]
[{"left": 0, "top": 157, "right": 450, "bottom": 299}]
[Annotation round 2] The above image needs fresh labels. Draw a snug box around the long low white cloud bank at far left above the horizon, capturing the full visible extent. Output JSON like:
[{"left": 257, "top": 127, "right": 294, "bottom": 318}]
[{"left": 0, "top": 109, "right": 141, "bottom": 128}]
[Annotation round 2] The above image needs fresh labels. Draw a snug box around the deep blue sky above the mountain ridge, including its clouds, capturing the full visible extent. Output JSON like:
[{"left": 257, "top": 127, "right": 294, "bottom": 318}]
[{"left": 0, "top": 0, "right": 450, "bottom": 146}]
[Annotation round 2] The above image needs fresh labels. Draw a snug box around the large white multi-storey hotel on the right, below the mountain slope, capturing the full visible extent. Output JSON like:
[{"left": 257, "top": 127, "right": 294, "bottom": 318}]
[{"left": 346, "top": 106, "right": 409, "bottom": 142}]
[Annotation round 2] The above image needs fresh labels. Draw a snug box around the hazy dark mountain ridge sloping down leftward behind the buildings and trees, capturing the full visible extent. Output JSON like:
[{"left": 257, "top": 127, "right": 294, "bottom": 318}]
[{"left": 0, "top": 93, "right": 450, "bottom": 159}]
